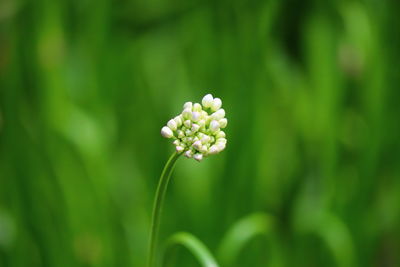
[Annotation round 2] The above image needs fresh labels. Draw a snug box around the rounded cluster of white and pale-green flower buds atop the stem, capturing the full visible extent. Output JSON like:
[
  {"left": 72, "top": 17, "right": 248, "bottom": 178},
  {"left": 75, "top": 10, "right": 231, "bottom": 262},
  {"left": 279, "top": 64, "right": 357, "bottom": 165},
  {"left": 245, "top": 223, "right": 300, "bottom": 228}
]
[{"left": 161, "top": 94, "right": 228, "bottom": 161}]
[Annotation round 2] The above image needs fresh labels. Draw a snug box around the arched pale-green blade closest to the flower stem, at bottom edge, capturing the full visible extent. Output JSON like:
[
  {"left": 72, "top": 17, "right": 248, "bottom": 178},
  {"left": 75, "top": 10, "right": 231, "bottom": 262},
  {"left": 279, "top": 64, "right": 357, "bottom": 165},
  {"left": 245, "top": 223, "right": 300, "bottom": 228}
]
[{"left": 165, "top": 232, "right": 219, "bottom": 267}]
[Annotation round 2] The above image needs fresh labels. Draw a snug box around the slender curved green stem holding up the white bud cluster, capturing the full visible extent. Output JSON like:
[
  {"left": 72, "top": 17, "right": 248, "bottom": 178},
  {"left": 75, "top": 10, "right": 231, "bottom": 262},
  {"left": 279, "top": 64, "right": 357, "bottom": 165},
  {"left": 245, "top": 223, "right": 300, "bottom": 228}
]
[{"left": 148, "top": 152, "right": 181, "bottom": 267}]
